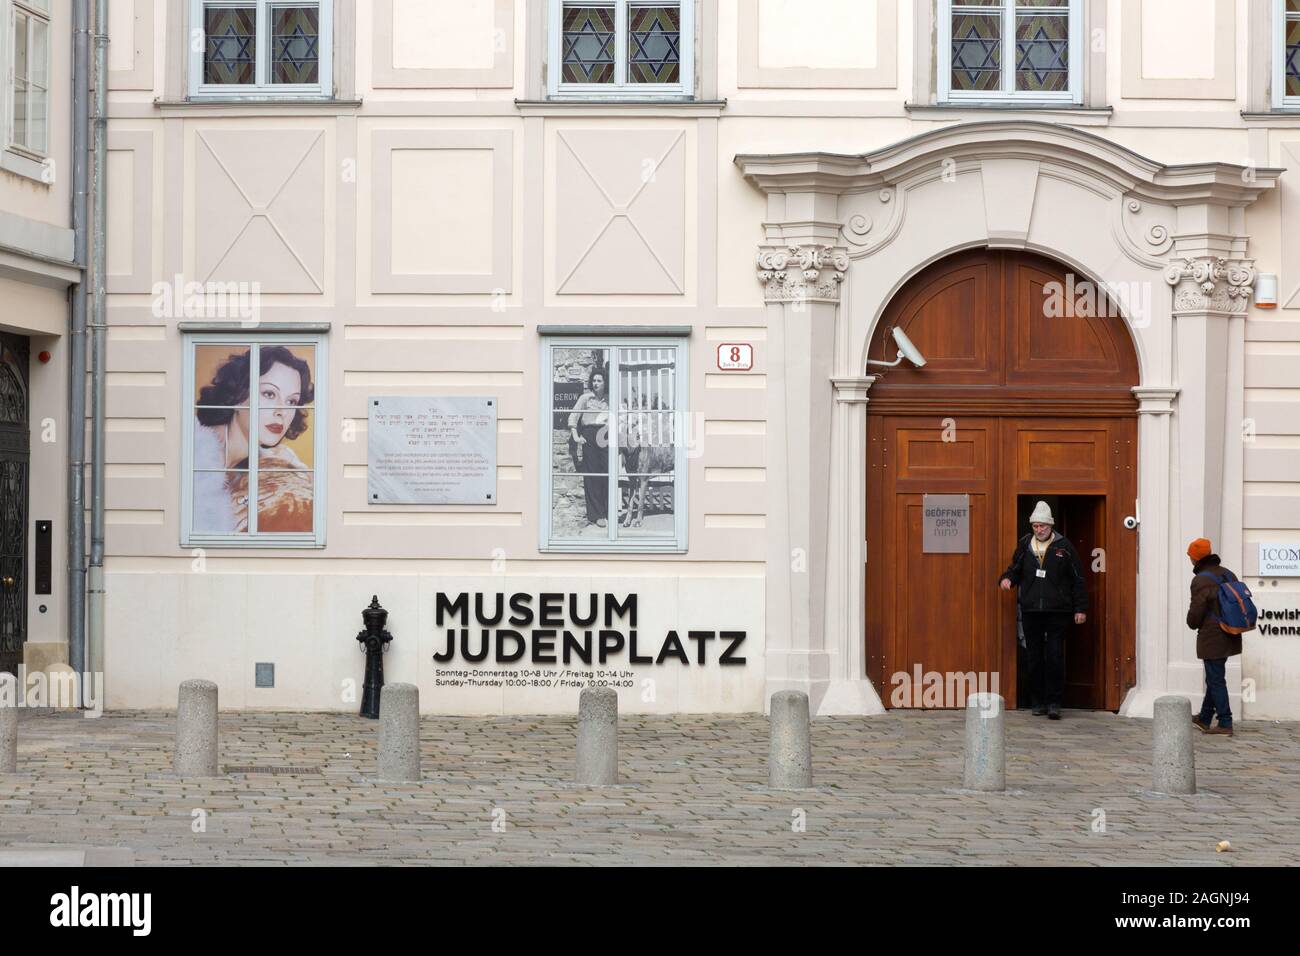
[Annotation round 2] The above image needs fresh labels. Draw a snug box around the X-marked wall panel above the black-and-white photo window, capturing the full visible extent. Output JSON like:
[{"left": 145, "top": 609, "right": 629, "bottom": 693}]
[{"left": 554, "top": 127, "right": 686, "bottom": 295}]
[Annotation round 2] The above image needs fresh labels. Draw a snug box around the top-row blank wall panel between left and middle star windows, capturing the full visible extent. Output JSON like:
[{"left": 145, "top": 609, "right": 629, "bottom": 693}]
[{"left": 371, "top": 0, "right": 515, "bottom": 90}]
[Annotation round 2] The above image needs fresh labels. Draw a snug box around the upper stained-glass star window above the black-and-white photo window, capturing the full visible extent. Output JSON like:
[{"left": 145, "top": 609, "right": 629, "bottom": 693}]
[{"left": 549, "top": 0, "right": 696, "bottom": 99}]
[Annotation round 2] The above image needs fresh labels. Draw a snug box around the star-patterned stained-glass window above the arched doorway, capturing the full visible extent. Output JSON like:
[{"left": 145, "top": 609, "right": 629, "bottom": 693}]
[{"left": 939, "top": 0, "right": 1083, "bottom": 103}]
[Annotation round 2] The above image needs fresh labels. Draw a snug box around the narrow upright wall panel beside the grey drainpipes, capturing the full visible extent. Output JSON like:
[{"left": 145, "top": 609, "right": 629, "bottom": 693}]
[{"left": 105, "top": 130, "right": 155, "bottom": 293}]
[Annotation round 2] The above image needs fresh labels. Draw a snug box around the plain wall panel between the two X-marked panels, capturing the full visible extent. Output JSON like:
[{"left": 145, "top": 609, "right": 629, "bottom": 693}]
[{"left": 371, "top": 130, "right": 515, "bottom": 294}]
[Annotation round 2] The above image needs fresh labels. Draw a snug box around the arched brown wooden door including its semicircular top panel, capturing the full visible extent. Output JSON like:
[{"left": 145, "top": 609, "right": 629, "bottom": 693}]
[{"left": 866, "top": 250, "right": 1138, "bottom": 710}]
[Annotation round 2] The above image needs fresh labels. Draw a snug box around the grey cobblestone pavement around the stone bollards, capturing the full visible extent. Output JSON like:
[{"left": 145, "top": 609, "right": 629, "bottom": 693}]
[{"left": 0, "top": 711, "right": 1300, "bottom": 866}]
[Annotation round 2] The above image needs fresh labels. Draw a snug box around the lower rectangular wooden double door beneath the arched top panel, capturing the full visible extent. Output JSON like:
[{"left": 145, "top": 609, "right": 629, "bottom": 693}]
[{"left": 867, "top": 415, "right": 1136, "bottom": 709}]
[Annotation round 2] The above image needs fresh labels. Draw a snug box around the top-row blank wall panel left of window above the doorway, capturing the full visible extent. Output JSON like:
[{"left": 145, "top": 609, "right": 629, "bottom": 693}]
[{"left": 737, "top": 0, "right": 898, "bottom": 90}]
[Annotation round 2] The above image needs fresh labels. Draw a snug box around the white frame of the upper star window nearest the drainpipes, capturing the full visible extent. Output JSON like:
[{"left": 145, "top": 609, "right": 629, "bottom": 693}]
[{"left": 189, "top": 0, "right": 334, "bottom": 100}]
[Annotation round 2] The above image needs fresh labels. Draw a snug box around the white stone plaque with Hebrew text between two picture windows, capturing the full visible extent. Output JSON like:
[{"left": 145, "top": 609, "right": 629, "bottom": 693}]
[{"left": 377, "top": 397, "right": 497, "bottom": 505}]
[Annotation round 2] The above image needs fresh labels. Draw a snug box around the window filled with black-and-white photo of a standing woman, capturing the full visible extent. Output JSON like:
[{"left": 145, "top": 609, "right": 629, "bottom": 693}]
[{"left": 540, "top": 338, "right": 689, "bottom": 551}]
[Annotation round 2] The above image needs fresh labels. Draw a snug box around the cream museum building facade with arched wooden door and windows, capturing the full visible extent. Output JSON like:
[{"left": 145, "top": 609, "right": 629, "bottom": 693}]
[{"left": 10, "top": 0, "right": 1300, "bottom": 718}]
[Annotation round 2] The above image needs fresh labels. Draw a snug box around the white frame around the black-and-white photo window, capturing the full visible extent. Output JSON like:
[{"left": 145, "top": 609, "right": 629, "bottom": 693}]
[{"left": 537, "top": 334, "right": 690, "bottom": 554}]
